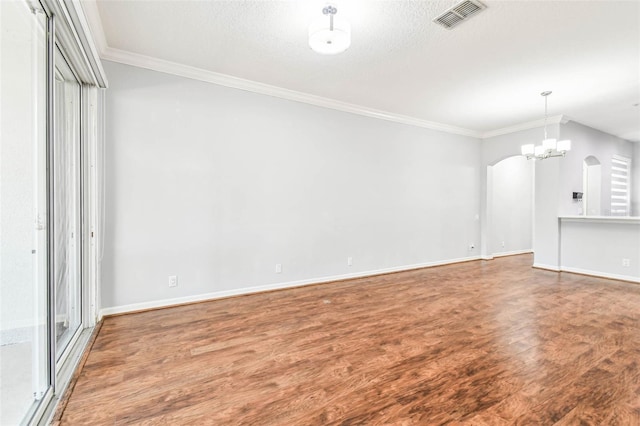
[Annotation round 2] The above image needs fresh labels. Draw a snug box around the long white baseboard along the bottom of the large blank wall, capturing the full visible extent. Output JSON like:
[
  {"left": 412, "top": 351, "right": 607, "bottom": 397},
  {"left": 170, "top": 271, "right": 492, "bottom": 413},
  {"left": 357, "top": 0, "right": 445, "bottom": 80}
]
[{"left": 99, "top": 256, "right": 480, "bottom": 320}]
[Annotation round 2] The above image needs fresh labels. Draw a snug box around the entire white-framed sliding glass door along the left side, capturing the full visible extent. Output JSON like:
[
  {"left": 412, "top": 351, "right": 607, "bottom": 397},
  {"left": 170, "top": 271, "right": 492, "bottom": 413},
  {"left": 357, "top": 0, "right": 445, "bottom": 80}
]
[{"left": 0, "top": 0, "right": 106, "bottom": 426}]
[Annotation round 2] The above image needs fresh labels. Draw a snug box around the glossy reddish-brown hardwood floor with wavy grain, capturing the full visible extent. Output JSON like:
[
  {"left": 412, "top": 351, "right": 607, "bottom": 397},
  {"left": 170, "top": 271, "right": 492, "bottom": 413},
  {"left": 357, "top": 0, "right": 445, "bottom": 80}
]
[{"left": 60, "top": 255, "right": 640, "bottom": 425}]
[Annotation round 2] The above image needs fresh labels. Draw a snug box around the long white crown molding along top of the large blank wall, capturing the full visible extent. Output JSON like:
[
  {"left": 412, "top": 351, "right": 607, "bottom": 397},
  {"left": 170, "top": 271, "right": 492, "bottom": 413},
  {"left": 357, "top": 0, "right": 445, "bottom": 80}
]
[{"left": 100, "top": 47, "right": 482, "bottom": 139}]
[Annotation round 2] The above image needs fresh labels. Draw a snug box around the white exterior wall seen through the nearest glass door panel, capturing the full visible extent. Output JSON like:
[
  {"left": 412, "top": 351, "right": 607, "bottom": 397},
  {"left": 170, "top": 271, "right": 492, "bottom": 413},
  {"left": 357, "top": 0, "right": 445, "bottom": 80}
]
[{"left": 0, "top": 2, "right": 37, "bottom": 334}]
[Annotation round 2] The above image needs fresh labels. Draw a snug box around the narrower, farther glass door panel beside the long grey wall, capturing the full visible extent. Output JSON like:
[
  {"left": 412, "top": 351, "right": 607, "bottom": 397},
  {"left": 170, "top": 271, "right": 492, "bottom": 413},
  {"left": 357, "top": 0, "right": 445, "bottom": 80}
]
[{"left": 53, "top": 49, "right": 82, "bottom": 361}]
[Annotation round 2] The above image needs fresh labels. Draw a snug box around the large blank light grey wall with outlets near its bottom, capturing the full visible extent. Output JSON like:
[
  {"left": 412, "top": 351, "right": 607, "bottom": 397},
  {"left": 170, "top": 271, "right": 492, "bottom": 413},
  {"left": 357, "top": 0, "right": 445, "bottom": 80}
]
[{"left": 102, "top": 62, "right": 481, "bottom": 308}]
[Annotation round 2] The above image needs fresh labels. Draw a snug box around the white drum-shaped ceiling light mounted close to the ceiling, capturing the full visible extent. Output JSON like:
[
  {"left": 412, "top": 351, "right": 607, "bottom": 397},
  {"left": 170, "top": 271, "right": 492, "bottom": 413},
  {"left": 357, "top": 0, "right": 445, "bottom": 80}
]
[{"left": 309, "top": 4, "right": 351, "bottom": 55}]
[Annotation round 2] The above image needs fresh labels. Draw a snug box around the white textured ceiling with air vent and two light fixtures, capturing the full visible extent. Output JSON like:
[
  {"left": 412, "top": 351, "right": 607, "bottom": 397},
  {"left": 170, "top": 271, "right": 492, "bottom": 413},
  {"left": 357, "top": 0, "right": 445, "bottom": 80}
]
[{"left": 85, "top": 0, "right": 640, "bottom": 141}]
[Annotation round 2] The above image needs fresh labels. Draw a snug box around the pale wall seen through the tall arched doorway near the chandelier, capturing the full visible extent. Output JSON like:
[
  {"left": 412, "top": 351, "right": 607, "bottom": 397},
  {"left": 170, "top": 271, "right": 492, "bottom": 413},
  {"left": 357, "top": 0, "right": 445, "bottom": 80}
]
[{"left": 490, "top": 155, "right": 534, "bottom": 255}]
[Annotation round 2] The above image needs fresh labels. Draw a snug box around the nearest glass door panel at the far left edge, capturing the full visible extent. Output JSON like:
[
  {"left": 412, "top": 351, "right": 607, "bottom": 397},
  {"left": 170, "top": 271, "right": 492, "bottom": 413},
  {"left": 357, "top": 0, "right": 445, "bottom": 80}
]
[{"left": 0, "top": 0, "right": 51, "bottom": 425}]
